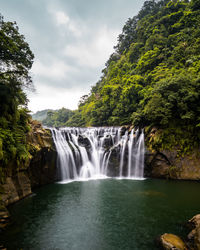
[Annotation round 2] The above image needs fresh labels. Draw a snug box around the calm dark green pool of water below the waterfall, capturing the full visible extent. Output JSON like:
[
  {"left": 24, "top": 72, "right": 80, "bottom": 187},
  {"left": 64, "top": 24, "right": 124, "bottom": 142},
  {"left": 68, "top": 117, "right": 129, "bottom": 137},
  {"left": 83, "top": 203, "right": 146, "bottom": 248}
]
[{"left": 3, "top": 179, "right": 200, "bottom": 250}]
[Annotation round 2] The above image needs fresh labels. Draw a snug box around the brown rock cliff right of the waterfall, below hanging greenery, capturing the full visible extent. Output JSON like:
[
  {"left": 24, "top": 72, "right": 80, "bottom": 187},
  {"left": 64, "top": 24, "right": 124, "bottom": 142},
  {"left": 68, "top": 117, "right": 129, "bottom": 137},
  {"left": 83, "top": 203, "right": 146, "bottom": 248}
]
[{"left": 145, "top": 129, "right": 200, "bottom": 180}]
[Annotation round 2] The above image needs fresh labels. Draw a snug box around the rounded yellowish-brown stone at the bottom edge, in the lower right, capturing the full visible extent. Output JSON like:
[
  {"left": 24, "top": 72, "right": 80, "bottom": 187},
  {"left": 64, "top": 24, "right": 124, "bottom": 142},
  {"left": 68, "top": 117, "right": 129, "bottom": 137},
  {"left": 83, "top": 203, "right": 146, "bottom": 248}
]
[{"left": 160, "top": 233, "right": 188, "bottom": 250}]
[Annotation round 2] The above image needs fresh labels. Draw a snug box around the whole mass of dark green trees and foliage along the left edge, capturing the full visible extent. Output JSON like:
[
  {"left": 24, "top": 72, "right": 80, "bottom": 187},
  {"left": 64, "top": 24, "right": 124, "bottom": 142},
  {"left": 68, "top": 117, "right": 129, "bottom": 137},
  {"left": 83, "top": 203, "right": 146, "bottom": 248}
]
[{"left": 0, "top": 15, "right": 34, "bottom": 170}]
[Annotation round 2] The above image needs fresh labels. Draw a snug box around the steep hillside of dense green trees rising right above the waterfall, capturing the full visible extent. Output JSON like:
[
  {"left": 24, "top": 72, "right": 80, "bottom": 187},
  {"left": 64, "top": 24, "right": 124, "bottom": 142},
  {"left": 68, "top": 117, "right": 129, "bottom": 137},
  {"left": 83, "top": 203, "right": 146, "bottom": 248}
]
[{"left": 69, "top": 0, "right": 200, "bottom": 150}]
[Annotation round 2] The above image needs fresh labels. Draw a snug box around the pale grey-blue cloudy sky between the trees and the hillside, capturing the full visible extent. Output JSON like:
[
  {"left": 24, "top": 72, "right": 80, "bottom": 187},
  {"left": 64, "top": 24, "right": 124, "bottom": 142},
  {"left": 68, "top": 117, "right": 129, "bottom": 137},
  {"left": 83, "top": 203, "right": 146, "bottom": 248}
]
[{"left": 0, "top": 0, "right": 144, "bottom": 112}]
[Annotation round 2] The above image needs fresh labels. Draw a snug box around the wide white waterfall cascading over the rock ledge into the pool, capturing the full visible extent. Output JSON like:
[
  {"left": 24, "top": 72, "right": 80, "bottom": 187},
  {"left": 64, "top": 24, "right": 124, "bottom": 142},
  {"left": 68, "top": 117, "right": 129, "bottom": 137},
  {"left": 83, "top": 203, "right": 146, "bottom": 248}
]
[{"left": 51, "top": 127, "right": 145, "bottom": 182}]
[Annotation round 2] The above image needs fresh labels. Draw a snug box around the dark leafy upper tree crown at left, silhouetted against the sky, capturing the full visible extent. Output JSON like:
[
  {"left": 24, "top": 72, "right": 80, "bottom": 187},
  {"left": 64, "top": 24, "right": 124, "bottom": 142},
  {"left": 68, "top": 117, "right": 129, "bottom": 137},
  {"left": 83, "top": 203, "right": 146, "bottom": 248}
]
[{"left": 0, "top": 16, "right": 34, "bottom": 86}]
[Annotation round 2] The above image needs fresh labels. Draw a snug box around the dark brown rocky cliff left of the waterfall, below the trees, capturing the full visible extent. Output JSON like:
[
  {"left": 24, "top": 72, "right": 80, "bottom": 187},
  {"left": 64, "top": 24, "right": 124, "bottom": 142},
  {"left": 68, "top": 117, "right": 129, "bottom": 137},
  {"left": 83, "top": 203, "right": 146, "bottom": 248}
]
[{"left": 0, "top": 121, "right": 56, "bottom": 228}]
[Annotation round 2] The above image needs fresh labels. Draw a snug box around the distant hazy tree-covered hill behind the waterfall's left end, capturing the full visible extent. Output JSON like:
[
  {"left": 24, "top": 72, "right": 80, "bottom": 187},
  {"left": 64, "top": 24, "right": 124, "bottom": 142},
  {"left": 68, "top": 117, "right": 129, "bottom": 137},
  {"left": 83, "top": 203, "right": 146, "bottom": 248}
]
[{"left": 42, "top": 108, "right": 74, "bottom": 127}]
